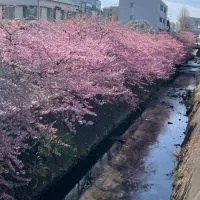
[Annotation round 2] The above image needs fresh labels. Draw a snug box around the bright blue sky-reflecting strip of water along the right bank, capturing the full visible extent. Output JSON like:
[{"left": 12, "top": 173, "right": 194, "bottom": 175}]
[{"left": 130, "top": 75, "right": 195, "bottom": 200}]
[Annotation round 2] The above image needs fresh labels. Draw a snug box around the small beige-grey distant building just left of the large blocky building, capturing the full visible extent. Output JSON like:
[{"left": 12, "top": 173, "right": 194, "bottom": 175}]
[{"left": 103, "top": 6, "right": 119, "bottom": 21}]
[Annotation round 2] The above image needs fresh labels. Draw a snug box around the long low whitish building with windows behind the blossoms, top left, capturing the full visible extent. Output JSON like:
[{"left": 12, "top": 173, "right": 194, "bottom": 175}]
[{"left": 0, "top": 0, "right": 80, "bottom": 20}]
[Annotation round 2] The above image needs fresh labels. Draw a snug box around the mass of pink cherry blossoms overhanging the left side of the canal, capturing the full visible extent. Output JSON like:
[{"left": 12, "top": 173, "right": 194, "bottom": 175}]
[{"left": 0, "top": 19, "right": 191, "bottom": 199}]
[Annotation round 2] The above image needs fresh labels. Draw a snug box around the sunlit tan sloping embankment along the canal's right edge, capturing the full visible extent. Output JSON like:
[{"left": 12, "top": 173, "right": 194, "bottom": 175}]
[{"left": 171, "top": 84, "right": 200, "bottom": 200}]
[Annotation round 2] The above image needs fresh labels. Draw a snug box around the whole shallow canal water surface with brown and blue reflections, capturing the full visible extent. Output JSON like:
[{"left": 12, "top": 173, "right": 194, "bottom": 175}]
[{"left": 65, "top": 63, "right": 199, "bottom": 200}]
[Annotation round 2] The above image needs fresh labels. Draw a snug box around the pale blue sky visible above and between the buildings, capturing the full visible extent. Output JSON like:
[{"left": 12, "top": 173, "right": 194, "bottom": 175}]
[{"left": 101, "top": 0, "right": 200, "bottom": 21}]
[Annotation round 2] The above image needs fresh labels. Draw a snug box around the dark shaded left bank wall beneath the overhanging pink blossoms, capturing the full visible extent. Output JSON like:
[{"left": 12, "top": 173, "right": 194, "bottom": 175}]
[{"left": 34, "top": 63, "right": 190, "bottom": 200}]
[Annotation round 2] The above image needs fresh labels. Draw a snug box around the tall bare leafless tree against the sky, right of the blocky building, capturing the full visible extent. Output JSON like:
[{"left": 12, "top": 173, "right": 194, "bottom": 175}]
[{"left": 178, "top": 8, "right": 191, "bottom": 32}]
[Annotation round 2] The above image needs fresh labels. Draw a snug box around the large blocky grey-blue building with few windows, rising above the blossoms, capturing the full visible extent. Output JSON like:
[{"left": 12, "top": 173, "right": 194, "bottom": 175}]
[{"left": 119, "top": 0, "right": 168, "bottom": 31}]
